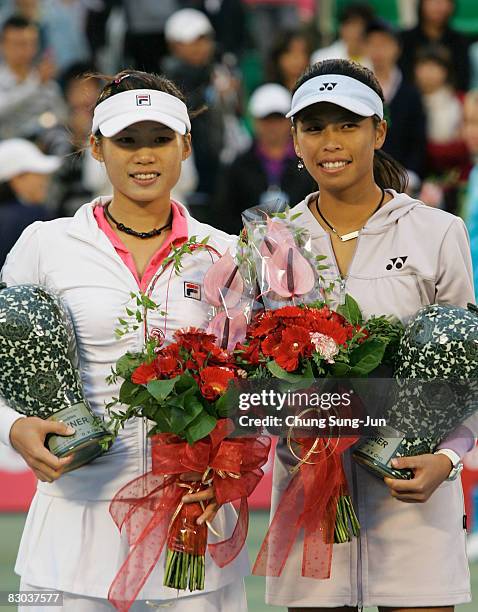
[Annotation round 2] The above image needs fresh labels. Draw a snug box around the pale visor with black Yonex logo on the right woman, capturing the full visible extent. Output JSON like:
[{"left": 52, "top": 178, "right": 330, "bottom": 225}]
[{"left": 286, "top": 74, "right": 383, "bottom": 119}]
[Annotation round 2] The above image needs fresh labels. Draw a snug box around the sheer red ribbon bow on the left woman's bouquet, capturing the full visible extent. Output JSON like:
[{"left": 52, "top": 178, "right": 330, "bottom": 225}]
[{"left": 108, "top": 419, "right": 270, "bottom": 612}]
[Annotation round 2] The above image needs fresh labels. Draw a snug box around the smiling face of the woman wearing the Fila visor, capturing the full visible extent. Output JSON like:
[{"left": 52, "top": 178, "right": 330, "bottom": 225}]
[{"left": 91, "top": 121, "right": 191, "bottom": 203}]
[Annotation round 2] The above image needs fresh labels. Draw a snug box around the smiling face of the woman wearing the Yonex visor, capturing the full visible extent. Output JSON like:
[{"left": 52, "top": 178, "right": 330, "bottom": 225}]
[{"left": 293, "top": 102, "right": 387, "bottom": 191}]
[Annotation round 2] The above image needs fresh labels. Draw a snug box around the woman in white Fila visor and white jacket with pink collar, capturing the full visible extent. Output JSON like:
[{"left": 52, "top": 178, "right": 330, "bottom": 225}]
[{"left": 0, "top": 71, "right": 249, "bottom": 612}]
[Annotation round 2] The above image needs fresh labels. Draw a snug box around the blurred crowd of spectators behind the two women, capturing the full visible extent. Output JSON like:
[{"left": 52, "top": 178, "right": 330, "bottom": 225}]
[{"left": 0, "top": 0, "right": 478, "bottom": 282}]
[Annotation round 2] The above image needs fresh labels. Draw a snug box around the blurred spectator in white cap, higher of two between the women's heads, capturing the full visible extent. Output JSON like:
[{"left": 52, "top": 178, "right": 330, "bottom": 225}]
[{"left": 163, "top": 9, "right": 248, "bottom": 215}]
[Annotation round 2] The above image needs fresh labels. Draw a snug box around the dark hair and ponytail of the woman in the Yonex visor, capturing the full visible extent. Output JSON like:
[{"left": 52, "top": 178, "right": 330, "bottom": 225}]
[{"left": 293, "top": 59, "right": 408, "bottom": 193}]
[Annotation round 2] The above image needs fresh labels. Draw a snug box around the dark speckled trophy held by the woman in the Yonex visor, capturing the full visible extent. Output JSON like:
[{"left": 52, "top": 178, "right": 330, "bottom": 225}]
[{"left": 353, "top": 304, "right": 478, "bottom": 479}]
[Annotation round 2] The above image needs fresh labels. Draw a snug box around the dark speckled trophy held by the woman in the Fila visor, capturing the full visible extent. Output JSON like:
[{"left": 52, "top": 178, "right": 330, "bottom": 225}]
[{"left": 0, "top": 283, "right": 108, "bottom": 471}]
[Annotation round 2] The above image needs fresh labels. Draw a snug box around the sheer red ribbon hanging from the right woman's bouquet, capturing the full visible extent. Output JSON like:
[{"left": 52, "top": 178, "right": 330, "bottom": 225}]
[{"left": 252, "top": 438, "right": 357, "bottom": 579}]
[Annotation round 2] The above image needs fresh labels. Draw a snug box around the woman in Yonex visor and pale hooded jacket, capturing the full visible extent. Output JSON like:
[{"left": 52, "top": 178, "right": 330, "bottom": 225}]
[{"left": 266, "top": 60, "right": 474, "bottom": 612}]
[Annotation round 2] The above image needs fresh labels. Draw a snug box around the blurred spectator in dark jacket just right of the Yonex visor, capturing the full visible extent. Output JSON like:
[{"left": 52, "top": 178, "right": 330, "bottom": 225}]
[{"left": 366, "top": 20, "right": 426, "bottom": 193}]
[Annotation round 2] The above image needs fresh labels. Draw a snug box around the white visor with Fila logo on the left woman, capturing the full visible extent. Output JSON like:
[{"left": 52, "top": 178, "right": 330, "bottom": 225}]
[{"left": 91, "top": 89, "right": 191, "bottom": 138}]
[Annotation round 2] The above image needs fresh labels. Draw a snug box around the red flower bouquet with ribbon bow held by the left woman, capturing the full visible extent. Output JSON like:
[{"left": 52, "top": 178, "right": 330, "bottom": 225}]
[{"left": 103, "top": 240, "right": 270, "bottom": 609}]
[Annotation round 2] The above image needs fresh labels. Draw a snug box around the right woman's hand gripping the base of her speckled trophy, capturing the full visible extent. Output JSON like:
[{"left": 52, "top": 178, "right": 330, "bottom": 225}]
[{"left": 384, "top": 454, "right": 453, "bottom": 504}]
